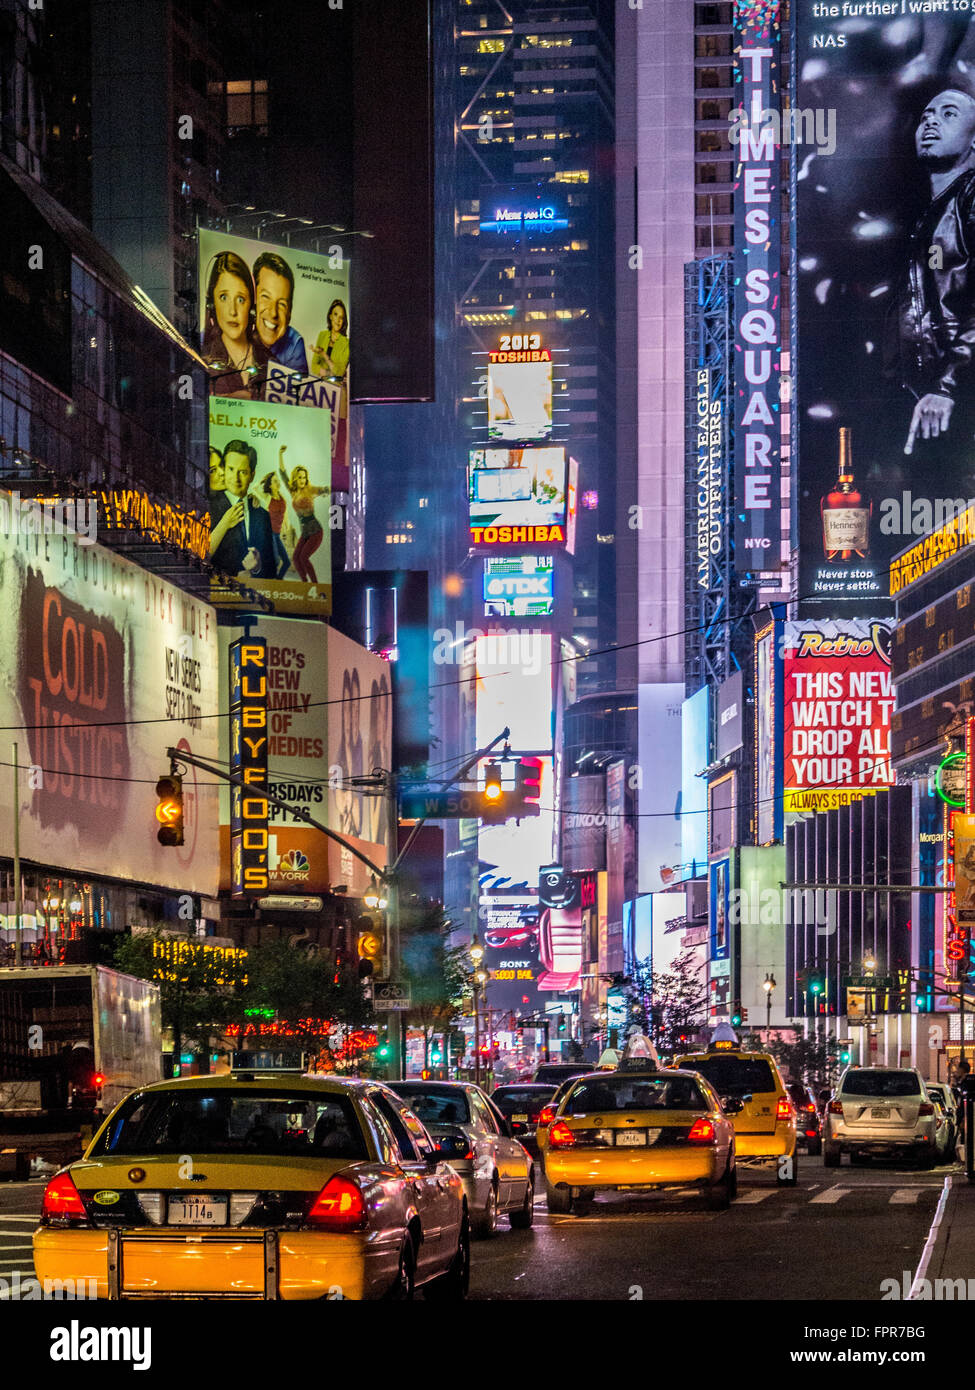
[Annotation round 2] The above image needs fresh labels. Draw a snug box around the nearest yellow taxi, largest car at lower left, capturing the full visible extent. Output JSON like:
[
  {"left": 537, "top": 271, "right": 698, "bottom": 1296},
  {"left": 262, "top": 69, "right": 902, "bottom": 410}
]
[{"left": 33, "top": 1063, "right": 470, "bottom": 1300}]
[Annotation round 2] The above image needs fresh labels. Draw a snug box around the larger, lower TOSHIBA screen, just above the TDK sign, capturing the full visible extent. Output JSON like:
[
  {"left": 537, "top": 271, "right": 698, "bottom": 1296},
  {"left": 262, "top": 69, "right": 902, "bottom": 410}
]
[{"left": 467, "top": 448, "right": 567, "bottom": 546}]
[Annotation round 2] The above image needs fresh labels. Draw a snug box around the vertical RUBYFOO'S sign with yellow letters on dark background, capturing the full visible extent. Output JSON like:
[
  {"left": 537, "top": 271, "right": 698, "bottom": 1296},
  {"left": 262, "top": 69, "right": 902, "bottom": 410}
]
[{"left": 229, "top": 637, "right": 270, "bottom": 898}]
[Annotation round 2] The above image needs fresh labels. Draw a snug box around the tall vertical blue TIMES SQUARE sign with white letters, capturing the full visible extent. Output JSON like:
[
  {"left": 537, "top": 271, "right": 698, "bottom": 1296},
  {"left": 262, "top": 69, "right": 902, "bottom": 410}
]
[{"left": 730, "top": 0, "right": 782, "bottom": 574}]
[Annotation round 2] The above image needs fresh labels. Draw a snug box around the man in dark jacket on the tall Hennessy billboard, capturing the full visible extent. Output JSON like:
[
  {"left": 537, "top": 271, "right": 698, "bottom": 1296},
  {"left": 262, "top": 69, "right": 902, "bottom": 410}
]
[{"left": 887, "top": 85, "right": 975, "bottom": 453}]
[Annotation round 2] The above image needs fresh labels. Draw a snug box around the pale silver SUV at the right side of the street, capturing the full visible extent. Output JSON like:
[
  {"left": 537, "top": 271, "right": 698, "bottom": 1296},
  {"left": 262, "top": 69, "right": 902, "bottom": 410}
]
[{"left": 822, "top": 1066, "right": 937, "bottom": 1168}]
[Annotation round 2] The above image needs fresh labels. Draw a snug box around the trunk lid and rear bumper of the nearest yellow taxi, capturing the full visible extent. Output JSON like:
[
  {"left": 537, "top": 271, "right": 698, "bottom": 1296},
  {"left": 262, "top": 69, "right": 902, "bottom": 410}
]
[{"left": 33, "top": 1155, "right": 375, "bottom": 1300}]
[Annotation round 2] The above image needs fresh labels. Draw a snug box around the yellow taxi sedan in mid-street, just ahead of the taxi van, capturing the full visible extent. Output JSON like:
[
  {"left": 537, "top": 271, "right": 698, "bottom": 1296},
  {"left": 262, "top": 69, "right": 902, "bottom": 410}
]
[{"left": 545, "top": 1058, "right": 737, "bottom": 1212}]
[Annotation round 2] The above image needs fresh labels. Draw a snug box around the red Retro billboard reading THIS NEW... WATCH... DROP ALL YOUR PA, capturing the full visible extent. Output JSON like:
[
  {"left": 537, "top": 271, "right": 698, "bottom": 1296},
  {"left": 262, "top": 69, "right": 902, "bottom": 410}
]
[{"left": 783, "top": 619, "right": 894, "bottom": 812}]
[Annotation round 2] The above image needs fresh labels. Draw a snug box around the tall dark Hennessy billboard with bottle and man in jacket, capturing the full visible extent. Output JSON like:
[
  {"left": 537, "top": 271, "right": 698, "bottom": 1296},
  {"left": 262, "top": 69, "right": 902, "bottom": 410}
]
[{"left": 793, "top": 0, "right": 975, "bottom": 614}]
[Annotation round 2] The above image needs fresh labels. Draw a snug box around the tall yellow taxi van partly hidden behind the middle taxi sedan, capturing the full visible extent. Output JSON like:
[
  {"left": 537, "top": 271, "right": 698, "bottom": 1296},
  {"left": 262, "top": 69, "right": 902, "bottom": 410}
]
[{"left": 675, "top": 1023, "right": 798, "bottom": 1187}]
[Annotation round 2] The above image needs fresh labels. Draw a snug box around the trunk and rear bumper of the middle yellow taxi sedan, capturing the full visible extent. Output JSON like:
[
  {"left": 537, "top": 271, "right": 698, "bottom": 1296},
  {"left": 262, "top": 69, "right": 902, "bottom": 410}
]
[{"left": 545, "top": 1109, "right": 726, "bottom": 1190}]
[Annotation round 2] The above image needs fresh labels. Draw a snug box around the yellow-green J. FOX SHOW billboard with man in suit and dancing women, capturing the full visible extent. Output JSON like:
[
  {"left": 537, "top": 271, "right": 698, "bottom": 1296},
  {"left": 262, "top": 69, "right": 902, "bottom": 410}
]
[{"left": 210, "top": 396, "right": 331, "bottom": 616}]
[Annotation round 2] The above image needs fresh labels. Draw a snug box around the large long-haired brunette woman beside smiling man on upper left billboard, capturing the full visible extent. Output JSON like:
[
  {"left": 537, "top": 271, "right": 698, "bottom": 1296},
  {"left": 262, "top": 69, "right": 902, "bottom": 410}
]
[{"left": 203, "top": 252, "right": 270, "bottom": 399}]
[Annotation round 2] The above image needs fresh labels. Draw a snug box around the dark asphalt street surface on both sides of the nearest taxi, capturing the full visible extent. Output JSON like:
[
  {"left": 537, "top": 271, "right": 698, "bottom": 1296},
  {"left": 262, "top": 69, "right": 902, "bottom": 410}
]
[{"left": 0, "top": 1156, "right": 956, "bottom": 1302}]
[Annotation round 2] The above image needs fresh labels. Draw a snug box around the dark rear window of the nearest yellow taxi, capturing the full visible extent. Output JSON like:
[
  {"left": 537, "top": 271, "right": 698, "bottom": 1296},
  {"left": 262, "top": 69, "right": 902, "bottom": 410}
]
[{"left": 93, "top": 1086, "right": 367, "bottom": 1159}]
